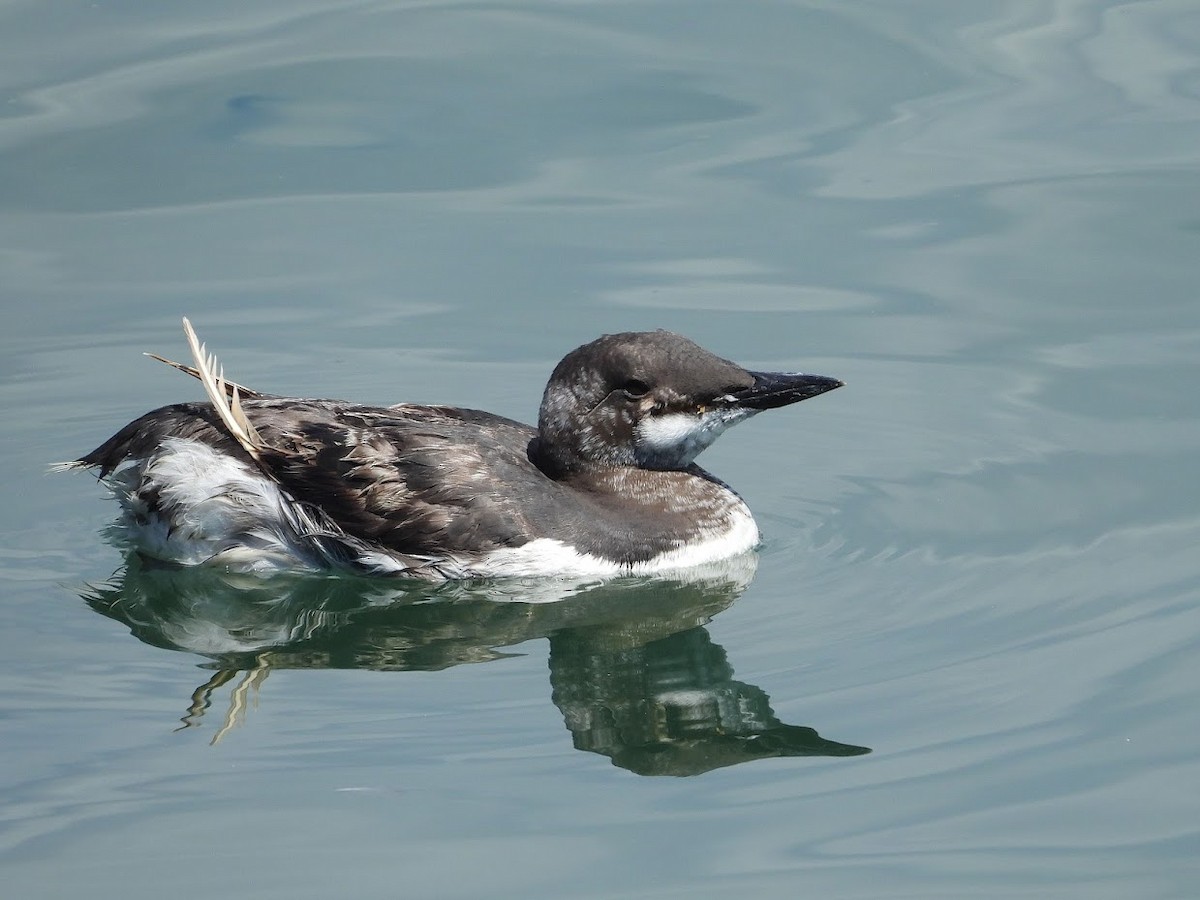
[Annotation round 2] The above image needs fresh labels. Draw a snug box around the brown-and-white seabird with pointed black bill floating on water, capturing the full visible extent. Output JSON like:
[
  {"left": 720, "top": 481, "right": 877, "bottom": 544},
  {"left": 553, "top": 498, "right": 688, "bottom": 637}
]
[{"left": 65, "top": 319, "right": 841, "bottom": 580}]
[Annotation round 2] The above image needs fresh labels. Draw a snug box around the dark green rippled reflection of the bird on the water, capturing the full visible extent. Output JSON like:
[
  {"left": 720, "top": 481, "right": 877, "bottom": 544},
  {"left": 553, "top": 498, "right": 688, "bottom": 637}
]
[{"left": 82, "top": 556, "right": 870, "bottom": 775}]
